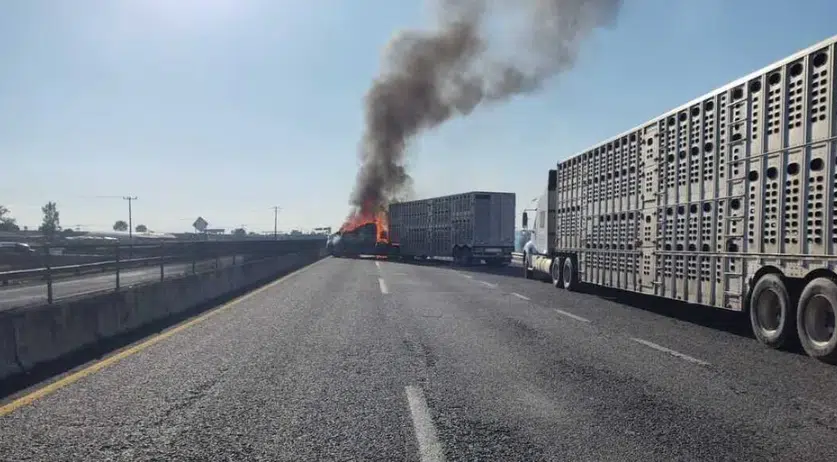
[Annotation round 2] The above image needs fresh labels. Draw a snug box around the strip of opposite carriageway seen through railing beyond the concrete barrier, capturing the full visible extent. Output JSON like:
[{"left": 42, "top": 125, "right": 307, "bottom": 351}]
[{"left": 0, "top": 257, "right": 232, "bottom": 311}]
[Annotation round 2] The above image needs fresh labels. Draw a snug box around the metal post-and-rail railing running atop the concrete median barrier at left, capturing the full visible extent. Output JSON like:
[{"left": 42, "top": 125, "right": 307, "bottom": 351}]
[{"left": 0, "top": 239, "right": 325, "bottom": 308}]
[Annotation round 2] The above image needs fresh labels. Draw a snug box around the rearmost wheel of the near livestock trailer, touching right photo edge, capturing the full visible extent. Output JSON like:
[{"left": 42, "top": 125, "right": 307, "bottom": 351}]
[{"left": 796, "top": 278, "right": 837, "bottom": 364}]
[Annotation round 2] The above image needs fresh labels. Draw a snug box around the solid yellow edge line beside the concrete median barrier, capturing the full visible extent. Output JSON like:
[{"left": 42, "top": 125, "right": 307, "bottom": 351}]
[{"left": 0, "top": 260, "right": 324, "bottom": 417}]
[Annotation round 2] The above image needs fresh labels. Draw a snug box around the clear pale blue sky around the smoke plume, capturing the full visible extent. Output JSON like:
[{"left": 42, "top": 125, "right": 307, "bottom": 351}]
[{"left": 0, "top": 0, "right": 837, "bottom": 231}]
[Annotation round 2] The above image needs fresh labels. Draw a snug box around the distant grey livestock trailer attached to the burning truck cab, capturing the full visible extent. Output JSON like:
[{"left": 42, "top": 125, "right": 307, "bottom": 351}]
[{"left": 389, "top": 191, "right": 515, "bottom": 266}]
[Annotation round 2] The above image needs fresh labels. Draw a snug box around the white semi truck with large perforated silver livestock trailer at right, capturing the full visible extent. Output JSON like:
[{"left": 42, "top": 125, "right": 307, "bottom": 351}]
[{"left": 523, "top": 36, "right": 837, "bottom": 363}]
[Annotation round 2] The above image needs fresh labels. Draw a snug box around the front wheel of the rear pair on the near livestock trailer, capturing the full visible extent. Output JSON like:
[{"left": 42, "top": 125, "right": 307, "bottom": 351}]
[{"left": 750, "top": 274, "right": 796, "bottom": 348}]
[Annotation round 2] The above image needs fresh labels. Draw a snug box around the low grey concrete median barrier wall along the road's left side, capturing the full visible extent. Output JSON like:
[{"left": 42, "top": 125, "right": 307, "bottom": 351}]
[{"left": 0, "top": 250, "right": 322, "bottom": 381}]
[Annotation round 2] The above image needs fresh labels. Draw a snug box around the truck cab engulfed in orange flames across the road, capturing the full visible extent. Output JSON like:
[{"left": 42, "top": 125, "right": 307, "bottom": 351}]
[{"left": 326, "top": 210, "right": 398, "bottom": 258}]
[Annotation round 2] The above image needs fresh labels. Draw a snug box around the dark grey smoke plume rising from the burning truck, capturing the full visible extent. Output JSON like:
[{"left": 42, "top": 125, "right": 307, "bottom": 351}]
[{"left": 350, "top": 0, "right": 622, "bottom": 214}]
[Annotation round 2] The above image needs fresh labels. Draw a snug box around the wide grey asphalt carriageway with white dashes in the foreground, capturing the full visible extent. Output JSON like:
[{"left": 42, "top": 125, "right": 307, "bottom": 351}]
[{"left": 0, "top": 259, "right": 837, "bottom": 462}]
